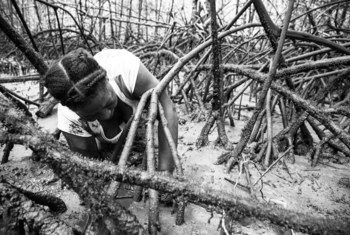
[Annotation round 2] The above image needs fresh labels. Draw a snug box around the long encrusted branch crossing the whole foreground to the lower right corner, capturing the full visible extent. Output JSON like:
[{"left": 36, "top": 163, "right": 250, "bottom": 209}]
[{"left": 0, "top": 96, "right": 350, "bottom": 234}]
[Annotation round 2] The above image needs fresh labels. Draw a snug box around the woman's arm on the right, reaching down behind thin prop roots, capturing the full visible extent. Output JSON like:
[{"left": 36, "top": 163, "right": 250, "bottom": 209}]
[{"left": 134, "top": 63, "right": 178, "bottom": 172}]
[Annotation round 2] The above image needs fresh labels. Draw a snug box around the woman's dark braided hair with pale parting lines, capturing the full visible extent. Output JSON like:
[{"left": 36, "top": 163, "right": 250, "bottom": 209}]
[{"left": 44, "top": 48, "right": 106, "bottom": 108}]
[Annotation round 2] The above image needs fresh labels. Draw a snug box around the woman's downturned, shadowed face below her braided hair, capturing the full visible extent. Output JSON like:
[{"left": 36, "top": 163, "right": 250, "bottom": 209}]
[{"left": 73, "top": 82, "right": 118, "bottom": 121}]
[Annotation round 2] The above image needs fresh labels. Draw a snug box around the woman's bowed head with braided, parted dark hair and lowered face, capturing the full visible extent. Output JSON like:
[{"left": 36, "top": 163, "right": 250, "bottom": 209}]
[{"left": 45, "top": 49, "right": 118, "bottom": 121}]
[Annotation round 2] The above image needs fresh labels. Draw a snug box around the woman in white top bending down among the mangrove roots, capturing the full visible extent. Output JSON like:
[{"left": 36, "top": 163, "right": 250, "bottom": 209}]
[{"left": 45, "top": 49, "right": 178, "bottom": 172}]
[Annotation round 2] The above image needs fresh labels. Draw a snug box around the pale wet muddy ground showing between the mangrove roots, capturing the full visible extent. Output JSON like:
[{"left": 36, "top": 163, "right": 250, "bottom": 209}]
[{"left": 0, "top": 82, "right": 350, "bottom": 234}]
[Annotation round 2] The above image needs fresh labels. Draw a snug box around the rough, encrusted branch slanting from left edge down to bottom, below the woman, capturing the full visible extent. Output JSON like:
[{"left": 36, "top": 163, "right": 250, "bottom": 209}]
[{"left": 0, "top": 95, "right": 143, "bottom": 234}]
